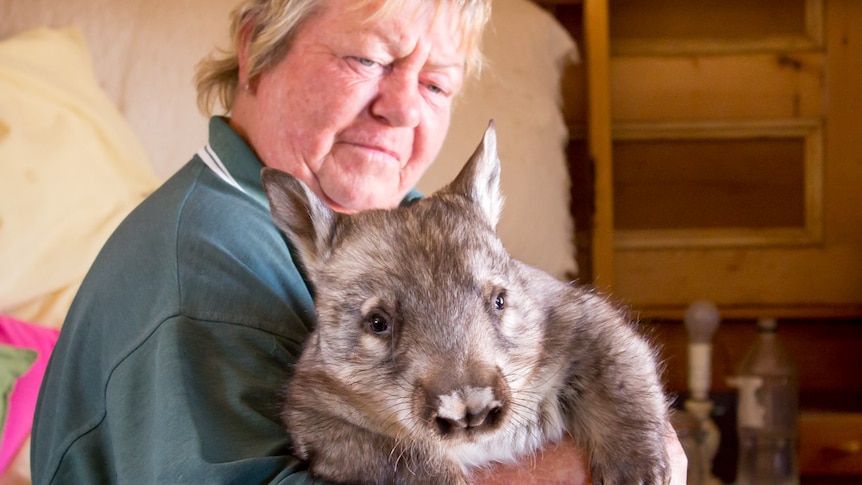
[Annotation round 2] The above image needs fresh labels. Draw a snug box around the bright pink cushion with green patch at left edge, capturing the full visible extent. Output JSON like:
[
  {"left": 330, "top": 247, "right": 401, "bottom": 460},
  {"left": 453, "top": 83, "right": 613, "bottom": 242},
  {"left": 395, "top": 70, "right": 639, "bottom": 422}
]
[{"left": 0, "top": 315, "right": 59, "bottom": 475}]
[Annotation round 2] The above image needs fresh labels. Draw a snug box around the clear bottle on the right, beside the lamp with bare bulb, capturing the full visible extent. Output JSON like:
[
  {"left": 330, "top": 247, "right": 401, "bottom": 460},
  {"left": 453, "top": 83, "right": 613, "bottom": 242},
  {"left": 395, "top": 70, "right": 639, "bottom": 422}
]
[{"left": 736, "top": 318, "right": 799, "bottom": 485}]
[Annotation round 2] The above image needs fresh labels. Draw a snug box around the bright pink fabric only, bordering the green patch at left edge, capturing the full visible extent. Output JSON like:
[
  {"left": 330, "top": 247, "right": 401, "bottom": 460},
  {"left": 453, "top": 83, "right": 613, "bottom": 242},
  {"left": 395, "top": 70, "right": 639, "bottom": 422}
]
[{"left": 0, "top": 315, "right": 60, "bottom": 472}]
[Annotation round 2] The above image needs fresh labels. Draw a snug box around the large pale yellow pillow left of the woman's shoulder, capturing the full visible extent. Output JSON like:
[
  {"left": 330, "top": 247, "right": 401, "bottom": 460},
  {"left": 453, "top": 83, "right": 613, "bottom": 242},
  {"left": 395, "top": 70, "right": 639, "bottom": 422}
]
[{"left": 0, "top": 28, "right": 158, "bottom": 328}]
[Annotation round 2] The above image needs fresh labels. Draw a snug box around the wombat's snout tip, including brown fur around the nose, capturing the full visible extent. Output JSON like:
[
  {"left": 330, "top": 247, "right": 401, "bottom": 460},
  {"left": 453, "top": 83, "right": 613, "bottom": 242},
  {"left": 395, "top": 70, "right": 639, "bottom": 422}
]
[{"left": 422, "top": 372, "right": 507, "bottom": 438}]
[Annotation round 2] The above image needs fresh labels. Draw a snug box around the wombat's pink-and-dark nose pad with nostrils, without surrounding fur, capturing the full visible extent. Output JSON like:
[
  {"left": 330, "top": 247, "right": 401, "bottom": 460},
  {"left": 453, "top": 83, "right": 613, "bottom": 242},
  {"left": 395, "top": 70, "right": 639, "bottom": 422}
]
[{"left": 434, "top": 387, "right": 502, "bottom": 436}]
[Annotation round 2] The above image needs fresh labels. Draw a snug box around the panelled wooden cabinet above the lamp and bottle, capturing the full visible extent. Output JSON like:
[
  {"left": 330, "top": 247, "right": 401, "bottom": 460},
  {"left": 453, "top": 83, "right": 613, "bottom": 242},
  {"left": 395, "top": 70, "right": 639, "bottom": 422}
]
[{"left": 541, "top": 0, "right": 862, "bottom": 318}]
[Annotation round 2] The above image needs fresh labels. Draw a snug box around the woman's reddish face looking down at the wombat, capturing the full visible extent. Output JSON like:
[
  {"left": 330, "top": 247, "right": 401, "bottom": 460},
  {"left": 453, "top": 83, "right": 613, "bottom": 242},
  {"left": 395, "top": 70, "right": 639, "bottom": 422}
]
[{"left": 231, "top": 0, "right": 466, "bottom": 212}]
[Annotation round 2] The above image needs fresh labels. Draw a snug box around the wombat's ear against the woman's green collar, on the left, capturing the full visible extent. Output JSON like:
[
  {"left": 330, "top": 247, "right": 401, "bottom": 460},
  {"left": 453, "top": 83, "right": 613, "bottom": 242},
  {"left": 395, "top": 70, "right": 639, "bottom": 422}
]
[{"left": 260, "top": 167, "right": 337, "bottom": 269}]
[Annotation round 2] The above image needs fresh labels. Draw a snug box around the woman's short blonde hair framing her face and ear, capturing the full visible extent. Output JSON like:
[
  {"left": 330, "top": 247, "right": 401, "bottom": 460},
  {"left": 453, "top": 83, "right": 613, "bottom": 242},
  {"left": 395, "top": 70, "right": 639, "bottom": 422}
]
[{"left": 195, "top": 0, "right": 491, "bottom": 114}]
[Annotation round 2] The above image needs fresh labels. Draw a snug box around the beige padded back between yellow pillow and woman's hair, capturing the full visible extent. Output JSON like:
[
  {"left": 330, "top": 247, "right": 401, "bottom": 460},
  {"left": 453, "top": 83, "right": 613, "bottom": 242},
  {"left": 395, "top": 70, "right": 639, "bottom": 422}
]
[{"left": 0, "top": 0, "right": 239, "bottom": 179}]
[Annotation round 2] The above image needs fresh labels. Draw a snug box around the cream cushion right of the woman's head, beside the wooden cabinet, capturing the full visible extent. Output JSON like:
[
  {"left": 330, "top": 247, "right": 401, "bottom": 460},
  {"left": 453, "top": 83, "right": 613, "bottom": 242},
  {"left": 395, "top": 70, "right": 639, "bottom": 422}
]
[{"left": 419, "top": 0, "right": 578, "bottom": 278}]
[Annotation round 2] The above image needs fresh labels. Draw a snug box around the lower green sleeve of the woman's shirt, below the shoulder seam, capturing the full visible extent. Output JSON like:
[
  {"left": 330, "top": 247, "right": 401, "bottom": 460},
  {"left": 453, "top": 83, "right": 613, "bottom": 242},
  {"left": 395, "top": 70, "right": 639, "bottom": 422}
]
[{"left": 37, "top": 317, "right": 330, "bottom": 484}]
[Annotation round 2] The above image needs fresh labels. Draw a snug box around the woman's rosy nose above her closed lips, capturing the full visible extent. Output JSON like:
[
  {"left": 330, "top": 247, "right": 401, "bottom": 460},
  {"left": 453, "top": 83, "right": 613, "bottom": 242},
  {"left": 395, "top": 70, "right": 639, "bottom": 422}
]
[{"left": 371, "top": 71, "right": 422, "bottom": 128}]
